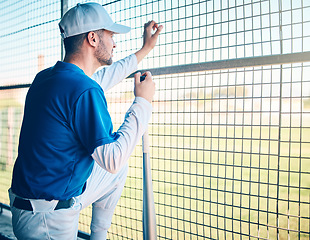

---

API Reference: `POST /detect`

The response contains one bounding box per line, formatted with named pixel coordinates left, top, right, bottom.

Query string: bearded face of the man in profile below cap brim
left=95, top=30, right=116, bottom=66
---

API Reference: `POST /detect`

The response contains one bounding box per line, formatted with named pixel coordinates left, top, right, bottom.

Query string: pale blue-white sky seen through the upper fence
left=0, top=0, right=310, bottom=96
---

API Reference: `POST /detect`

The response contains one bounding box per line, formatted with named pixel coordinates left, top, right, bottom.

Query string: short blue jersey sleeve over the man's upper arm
left=72, top=88, right=119, bottom=154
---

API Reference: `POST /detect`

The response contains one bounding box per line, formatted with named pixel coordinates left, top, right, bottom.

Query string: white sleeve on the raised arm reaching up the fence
left=92, top=54, right=138, bottom=91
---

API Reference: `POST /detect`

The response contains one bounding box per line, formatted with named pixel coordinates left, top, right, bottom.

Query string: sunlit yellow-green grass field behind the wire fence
left=0, top=122, right=310, bottom=239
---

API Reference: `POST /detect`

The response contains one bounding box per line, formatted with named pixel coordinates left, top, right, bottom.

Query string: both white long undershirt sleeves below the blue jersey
left=92, top=54, right=152, bottom=173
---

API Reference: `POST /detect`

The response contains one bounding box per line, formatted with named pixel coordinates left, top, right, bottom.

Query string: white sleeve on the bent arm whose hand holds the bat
left=92, top=97, right=152, bottom=173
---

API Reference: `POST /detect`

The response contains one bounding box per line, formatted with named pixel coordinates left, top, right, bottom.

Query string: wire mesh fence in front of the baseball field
left=0, top=0, right=310, bottom=239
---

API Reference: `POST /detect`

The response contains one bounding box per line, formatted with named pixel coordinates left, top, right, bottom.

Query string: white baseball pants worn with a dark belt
left=9, top=162, right=128, bottom=240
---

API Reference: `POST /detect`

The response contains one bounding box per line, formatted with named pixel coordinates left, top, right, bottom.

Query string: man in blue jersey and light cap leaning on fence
left=9, top=3, right=162, bottom=239
